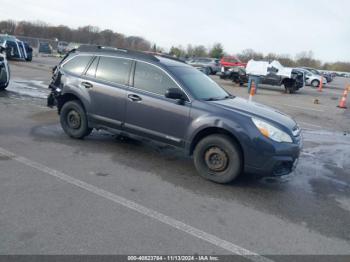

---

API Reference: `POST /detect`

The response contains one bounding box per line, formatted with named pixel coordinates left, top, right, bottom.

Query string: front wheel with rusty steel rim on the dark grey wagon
left=193, top=134, right=242, bottom=184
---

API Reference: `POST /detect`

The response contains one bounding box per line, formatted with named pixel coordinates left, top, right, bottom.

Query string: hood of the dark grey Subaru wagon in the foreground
left=214, top=97, right=296, bottom=131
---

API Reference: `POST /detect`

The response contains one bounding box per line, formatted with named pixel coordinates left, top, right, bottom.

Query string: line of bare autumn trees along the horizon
left=0, top=20, right=350, bottom=72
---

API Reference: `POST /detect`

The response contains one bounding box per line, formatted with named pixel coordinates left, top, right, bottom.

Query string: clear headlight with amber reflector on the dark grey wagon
left=252, top=118, right=293, bottom=143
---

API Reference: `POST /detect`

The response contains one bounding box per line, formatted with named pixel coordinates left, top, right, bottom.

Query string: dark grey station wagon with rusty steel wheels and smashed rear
left=48, top=46, right=302, bottom=183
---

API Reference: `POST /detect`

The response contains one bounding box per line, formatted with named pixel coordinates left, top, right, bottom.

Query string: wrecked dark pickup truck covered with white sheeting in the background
left=246, top=60, right=305, bottom=94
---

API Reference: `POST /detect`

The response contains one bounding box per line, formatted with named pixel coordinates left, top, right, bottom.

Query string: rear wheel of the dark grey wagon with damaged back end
left=60, top=100, right=92, bottom=139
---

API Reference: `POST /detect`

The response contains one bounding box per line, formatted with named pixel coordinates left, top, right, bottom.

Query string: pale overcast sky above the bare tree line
left=0, top=0, right=350, bottom=62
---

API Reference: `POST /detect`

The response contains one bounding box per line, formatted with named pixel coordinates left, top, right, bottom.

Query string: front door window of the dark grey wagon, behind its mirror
left=134, top=62, right=178, bottom=95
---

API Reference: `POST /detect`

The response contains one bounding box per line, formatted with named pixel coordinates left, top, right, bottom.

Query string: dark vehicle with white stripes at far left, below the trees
left=0, top=35, right=33, bottom=61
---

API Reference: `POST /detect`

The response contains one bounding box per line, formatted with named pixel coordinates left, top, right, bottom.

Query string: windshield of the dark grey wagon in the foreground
left=171, top=66, right=231, bottom=100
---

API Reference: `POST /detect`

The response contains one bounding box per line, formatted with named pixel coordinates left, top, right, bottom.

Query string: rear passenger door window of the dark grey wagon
left=96, top=57, right=132, bottom=85
